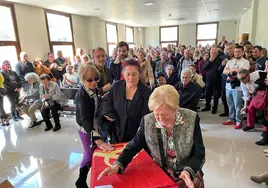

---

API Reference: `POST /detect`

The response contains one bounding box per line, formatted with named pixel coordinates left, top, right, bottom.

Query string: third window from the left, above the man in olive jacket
left=106, top=22, right=118, bottom=56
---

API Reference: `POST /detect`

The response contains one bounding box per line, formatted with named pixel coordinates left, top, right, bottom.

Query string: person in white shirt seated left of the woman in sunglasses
left=62, top=65, right=79, bottom=88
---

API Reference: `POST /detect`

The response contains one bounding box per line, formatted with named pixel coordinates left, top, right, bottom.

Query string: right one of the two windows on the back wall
left=196, top=23, right=218, bottom=46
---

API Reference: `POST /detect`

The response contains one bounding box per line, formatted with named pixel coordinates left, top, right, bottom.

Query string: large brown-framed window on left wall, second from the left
left=45, top=10, right=74, bottom=57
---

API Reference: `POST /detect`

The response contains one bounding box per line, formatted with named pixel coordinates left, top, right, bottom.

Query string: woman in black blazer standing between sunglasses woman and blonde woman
left=102, top=60, right=151, bottom=142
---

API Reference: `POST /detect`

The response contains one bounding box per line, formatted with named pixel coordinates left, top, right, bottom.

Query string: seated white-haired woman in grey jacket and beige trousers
left=18, top=72, right=42, bottom=129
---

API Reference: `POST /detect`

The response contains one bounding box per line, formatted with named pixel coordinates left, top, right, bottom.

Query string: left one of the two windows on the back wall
left=160, top=26, right=178, bottom=47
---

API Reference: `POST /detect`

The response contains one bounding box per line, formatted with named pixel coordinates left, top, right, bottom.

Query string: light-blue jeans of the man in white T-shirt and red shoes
left=226, top=89, right=244, bottom=123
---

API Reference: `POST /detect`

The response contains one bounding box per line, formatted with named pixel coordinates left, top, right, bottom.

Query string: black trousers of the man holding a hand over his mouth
left=206, top=81, right=221, bottom=109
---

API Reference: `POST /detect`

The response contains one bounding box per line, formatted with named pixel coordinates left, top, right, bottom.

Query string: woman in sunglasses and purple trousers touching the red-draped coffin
left=75, top=64, right=113, bottom=188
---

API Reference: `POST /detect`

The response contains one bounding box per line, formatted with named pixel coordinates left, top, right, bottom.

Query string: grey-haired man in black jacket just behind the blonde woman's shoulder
left=175, top=68, right=201, bottom=111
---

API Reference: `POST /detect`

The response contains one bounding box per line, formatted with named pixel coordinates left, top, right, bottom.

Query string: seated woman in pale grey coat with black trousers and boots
left=39, top=74, right=68, bottom=132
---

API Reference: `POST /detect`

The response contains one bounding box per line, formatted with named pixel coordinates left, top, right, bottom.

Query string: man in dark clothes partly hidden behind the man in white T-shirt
left=219, top=42, right=234, bottom=117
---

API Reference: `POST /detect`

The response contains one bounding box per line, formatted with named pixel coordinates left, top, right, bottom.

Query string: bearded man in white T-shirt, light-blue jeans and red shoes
left=223, top=46, right=250, bottom=129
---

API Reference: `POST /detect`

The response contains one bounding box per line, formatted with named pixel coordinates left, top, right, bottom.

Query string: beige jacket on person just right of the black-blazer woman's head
left=140, top=61, right=154, bottom=87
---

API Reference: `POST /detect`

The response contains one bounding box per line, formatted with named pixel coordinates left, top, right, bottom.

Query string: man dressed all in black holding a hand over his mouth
left=202, top=47, right=221, bottom=114
